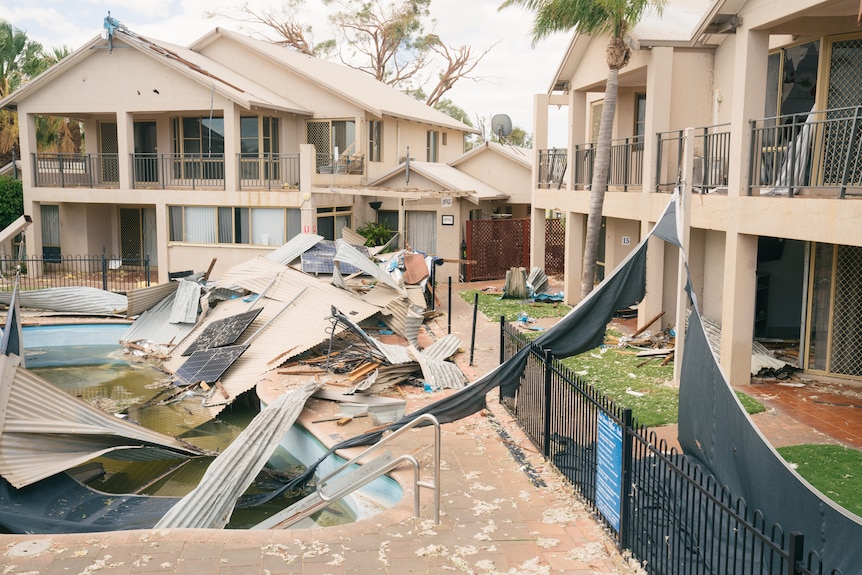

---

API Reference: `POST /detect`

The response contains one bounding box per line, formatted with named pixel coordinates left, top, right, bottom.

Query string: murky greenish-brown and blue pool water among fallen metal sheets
left=16, top=324, right=402, bottom=528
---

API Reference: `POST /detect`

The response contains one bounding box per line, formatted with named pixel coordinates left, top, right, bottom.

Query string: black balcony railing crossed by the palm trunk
left=574, top=136, right=644, bottom=192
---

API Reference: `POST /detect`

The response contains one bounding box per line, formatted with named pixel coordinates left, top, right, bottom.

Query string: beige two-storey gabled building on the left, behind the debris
left=0, top=22, right=530, bottom=281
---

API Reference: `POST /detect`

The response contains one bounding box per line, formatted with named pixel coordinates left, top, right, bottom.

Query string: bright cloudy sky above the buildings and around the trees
left=6, top=0, right=569, bottom=147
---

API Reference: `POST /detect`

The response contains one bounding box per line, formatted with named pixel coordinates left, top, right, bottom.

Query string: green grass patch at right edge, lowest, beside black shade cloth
left=778, top=445, right=862, bottom=516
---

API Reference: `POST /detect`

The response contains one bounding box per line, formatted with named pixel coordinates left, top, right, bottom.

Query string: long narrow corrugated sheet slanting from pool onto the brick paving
left=155, top=383, right=321, bottom=529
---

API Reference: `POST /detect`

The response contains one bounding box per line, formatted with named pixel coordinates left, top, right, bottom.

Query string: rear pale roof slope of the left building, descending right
left=190, top=28, right=478, bottom=133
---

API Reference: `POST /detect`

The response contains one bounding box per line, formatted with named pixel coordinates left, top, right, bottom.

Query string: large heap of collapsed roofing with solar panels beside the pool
left=122, top=233, right=467, bottom=435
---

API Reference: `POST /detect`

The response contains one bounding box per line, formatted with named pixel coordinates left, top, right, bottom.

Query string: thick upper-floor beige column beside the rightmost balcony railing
left=727, top=29, right=769, bottom=196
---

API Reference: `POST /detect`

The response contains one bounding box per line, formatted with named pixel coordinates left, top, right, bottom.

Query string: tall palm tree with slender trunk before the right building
left=500, top=0, right=666, bottom=299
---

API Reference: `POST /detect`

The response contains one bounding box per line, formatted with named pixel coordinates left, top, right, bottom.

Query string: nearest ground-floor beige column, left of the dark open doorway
left=721, top=231, right=757, bottom=385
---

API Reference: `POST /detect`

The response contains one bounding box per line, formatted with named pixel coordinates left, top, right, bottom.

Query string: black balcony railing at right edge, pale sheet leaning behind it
left=748, top=107, right=862, bottom=198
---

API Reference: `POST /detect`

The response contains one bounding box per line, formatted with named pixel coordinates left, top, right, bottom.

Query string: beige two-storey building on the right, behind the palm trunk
left=532, top=0, right=862, bottom=384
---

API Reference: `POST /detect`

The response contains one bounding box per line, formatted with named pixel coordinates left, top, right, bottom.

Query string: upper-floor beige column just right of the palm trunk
left=643, top=47, right=673, bottom=193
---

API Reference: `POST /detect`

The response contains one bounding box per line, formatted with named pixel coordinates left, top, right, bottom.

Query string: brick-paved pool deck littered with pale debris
left=0, top=282, right=643, bottom=575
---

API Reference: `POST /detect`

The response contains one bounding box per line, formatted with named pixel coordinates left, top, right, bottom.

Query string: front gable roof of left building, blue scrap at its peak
left=0, top=29, right=311, bottom=115
